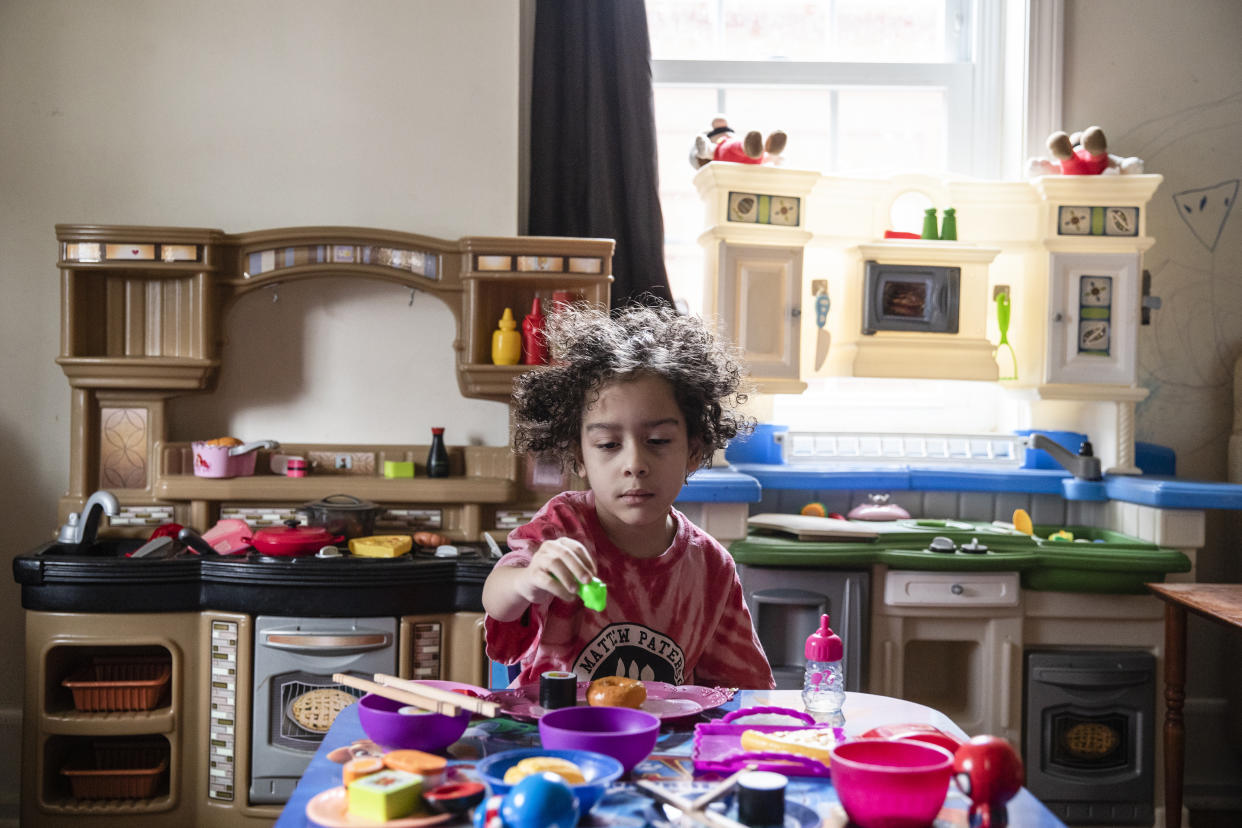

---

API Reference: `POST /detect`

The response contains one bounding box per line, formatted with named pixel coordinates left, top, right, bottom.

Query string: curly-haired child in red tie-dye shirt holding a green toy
left=483, top=305, right=775, bottom=688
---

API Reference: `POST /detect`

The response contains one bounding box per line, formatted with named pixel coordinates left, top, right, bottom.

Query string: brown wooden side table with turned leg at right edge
left=1148, top=583, right=1242, bottom=828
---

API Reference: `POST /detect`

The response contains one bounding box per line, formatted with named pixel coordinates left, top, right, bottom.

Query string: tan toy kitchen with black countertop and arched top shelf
left=15, top=225, right=612, bottom=826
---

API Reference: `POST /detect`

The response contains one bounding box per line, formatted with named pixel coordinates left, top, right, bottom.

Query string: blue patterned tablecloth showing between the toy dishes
left=276, top=690, right=1064, bottom=828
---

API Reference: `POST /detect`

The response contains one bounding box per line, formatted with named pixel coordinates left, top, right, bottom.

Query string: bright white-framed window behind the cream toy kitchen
left=646, top=0, right=1061, bottom=310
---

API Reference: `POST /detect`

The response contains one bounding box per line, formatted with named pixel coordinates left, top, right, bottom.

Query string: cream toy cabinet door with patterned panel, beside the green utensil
left=1046, top=253, right=1139, bottom=385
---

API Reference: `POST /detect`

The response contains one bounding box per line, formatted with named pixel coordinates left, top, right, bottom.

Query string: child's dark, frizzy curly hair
left=513, top=303, right=754, bottom=467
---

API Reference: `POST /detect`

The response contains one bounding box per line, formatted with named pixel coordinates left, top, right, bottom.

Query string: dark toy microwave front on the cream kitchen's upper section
left=862, top=261, right=961, bottom=334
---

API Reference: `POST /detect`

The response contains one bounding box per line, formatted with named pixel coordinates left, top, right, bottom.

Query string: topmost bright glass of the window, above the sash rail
left=647, top=0, right=953, bottom=63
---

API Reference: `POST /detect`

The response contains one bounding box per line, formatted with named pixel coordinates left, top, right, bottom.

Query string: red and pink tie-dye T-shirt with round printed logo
left=486, top=490, right=775, bottom=689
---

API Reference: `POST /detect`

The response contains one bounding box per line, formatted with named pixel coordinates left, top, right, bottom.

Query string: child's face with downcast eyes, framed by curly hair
left=581, top=376, right=698, bottom=545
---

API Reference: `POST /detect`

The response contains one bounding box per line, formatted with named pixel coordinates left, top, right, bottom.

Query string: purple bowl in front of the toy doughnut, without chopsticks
left=539, top=706, right=660, bottom=773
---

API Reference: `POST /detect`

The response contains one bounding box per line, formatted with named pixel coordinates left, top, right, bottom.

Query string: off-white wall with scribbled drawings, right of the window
left=1064, top=0, right=1242, bottom=808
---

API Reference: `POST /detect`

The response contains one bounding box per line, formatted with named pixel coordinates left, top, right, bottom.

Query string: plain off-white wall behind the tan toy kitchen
left=0, top=0, right=519, bottom=808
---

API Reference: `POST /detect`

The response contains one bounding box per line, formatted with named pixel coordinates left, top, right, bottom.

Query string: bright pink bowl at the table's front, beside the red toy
left=828, top=739, right=953, bottom=828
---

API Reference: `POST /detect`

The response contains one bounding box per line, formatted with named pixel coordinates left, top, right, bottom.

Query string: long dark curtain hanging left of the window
left=528, top=0, right=672, bottom=308
